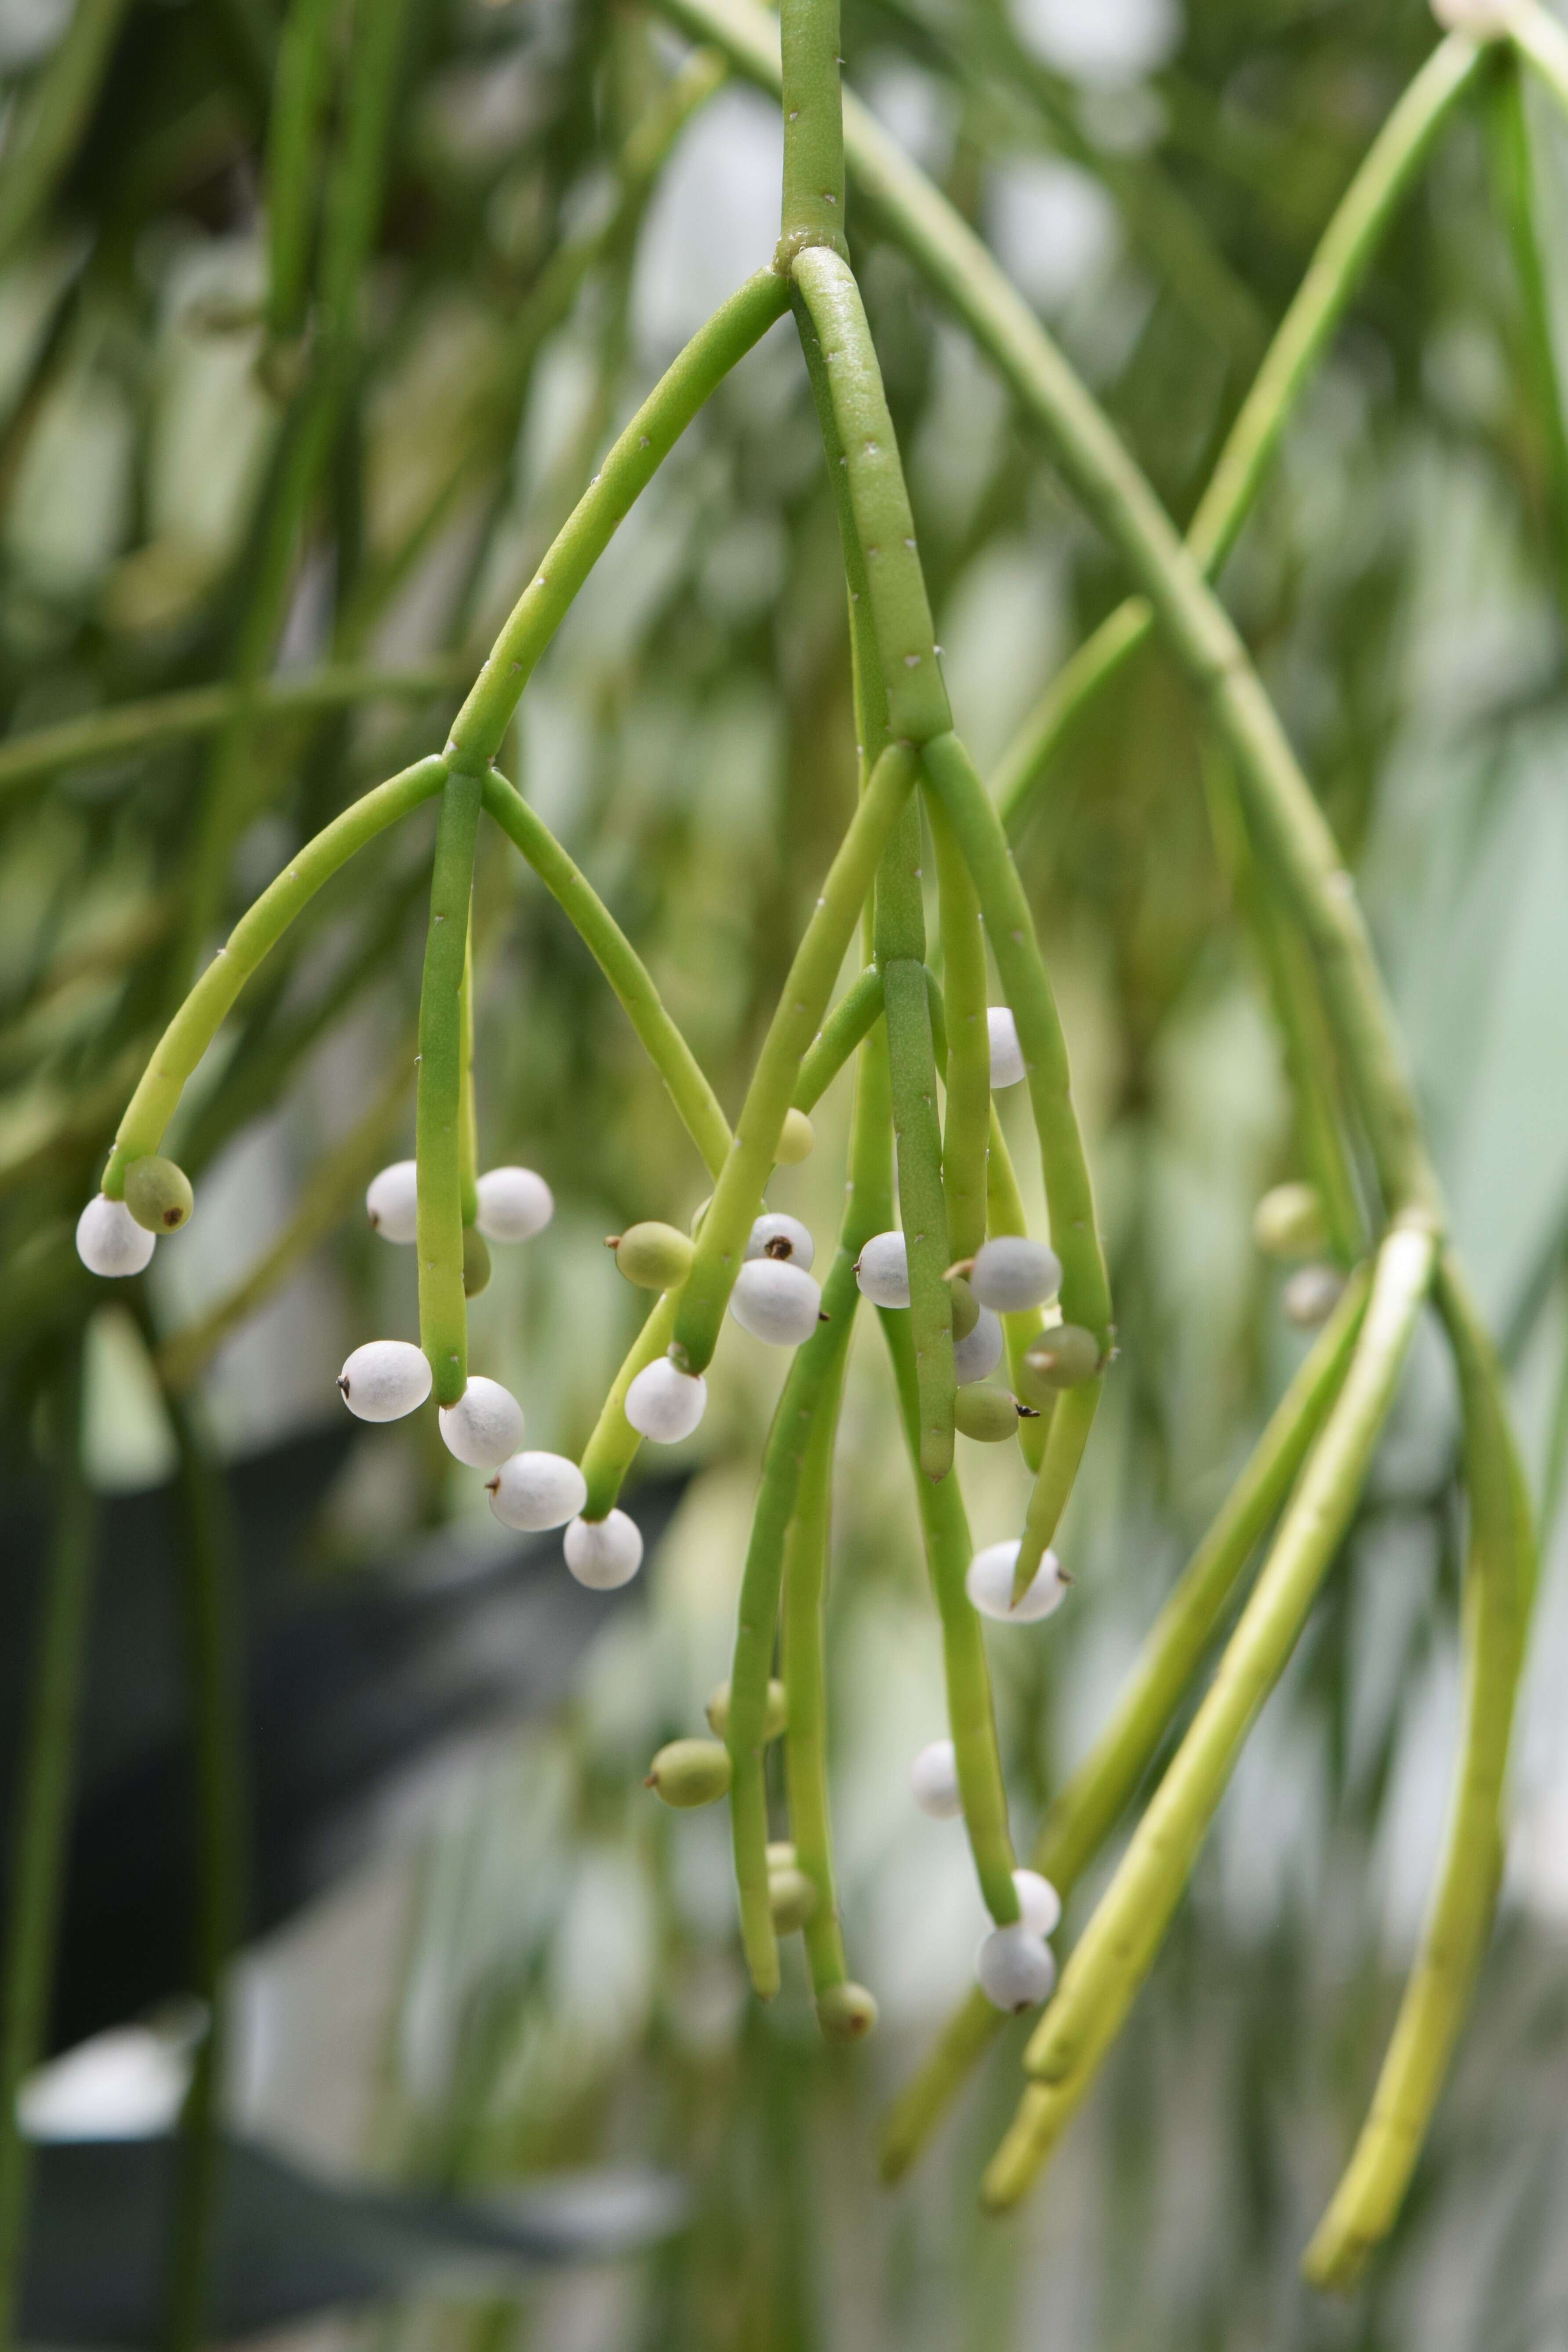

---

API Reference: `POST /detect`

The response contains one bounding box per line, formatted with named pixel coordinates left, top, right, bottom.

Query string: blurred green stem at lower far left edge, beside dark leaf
left=0, top=1348, right=94, bottom=2352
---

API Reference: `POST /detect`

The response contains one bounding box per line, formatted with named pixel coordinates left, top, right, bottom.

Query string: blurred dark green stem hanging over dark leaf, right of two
left=164, top=1390, right=249, bottom=2352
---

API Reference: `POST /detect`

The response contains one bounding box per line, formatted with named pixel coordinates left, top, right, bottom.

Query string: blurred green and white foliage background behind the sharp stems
left=0, top=0, right=1568, bottom=2352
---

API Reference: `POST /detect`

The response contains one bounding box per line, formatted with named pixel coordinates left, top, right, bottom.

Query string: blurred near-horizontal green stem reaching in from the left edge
left=0, top=654, right=468, bottom=802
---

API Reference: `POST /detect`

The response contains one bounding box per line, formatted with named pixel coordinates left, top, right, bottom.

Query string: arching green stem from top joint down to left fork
left=451, top=270, right=790, bottom=774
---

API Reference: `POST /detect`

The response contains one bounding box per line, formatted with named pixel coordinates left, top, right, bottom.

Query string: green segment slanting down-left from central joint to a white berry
left=675, top=743, right=914, bottom=1371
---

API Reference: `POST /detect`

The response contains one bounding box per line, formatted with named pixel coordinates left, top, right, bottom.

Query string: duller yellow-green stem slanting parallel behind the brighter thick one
left=881, top=1273, right=1368, bottom=2181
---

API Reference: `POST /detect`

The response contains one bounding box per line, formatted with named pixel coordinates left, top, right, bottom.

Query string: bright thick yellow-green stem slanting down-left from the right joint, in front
left=985, top=1223, right=1437, bottom=2209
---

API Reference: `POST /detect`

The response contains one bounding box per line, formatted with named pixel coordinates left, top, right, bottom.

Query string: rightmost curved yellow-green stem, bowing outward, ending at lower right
left=1302, top=1254, right=1535, bottom=2289
